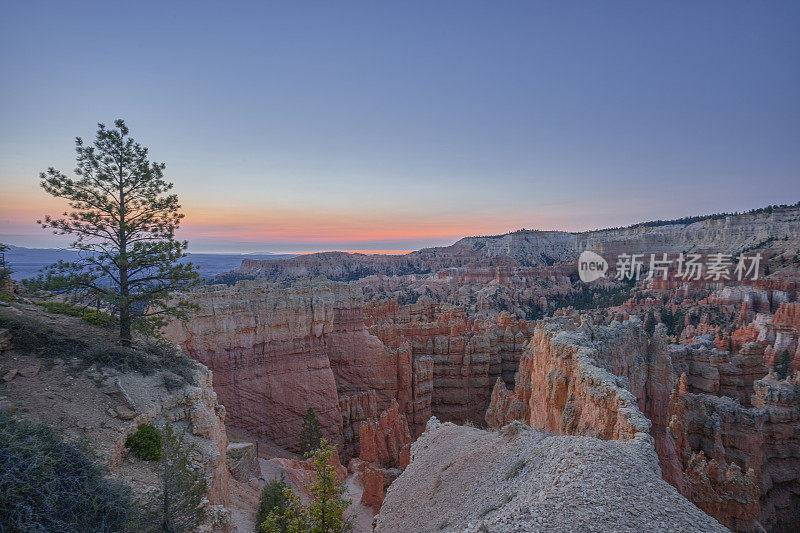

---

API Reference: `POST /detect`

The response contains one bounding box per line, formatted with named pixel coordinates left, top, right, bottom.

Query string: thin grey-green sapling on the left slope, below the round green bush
left=151, top=424, right=208, bottom=533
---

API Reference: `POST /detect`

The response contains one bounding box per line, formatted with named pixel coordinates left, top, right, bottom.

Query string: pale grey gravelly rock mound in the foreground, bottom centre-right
left=377, top=418, right=727, bottom=532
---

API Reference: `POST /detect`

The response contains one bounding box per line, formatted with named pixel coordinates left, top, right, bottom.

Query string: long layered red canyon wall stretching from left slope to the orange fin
left=164, top=280, right=531, bottom=460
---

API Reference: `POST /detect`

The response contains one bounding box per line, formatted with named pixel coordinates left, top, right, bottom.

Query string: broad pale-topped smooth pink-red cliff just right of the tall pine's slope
left=163, top=280, right=400, bottom=454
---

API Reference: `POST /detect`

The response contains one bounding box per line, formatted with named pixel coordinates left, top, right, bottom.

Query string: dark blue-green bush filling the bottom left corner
left=0, top=412, right=133, bottom=532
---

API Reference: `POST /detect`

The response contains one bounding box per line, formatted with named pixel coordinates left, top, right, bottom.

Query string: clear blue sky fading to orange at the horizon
left=0, top=0, right=800, bottom=253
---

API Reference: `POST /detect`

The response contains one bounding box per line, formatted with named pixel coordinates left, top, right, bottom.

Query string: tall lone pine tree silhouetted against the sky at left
left=38, top=120, right=198, bottom=345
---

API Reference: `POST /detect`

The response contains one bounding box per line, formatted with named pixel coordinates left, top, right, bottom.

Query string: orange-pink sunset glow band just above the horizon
left=0, top=187, right=564, bottom=246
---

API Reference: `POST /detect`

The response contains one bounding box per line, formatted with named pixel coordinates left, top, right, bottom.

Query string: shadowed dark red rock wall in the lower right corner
left=669, top=339, right=800, bottom=531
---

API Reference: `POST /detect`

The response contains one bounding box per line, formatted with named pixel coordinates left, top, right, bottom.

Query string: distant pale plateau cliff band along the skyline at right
left=231, top=206, right=800, bottom=281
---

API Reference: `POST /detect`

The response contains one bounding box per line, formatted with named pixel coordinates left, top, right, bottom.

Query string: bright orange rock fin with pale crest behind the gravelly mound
left=486, top=319, right=671, bottom=440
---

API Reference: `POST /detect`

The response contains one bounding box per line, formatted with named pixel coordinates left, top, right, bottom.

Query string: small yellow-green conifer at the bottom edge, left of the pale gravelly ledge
left=306, top=439, right=351, bottom=533
